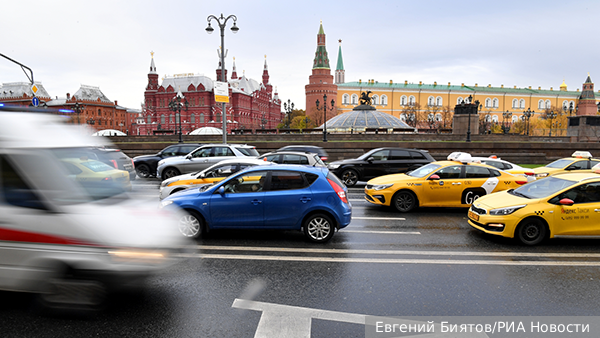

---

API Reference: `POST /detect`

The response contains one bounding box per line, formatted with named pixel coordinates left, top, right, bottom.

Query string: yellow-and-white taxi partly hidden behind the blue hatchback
left=160, top=157, right=275, bottom=200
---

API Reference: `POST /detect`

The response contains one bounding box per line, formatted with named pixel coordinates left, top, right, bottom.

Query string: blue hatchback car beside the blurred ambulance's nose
left=161, top=165, right=352, bottom=243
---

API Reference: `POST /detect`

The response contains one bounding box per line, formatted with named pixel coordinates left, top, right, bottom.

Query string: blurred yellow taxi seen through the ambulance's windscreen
left=61, top=157, right=131, bottom=192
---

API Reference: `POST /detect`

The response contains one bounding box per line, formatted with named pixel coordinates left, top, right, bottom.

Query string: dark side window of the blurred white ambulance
left=0, top=156, right=46, bottom=210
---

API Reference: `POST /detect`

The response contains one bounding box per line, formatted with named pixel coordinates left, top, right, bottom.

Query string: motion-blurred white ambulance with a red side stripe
left=0, top=104, right=188, bottom=312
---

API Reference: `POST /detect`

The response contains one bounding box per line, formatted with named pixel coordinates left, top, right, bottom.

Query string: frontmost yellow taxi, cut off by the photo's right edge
left=468, top=172, right=600, bottom=245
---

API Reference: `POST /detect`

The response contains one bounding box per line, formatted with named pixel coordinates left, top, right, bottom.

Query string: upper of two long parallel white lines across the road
left=192, top=245, right=600, bottom=258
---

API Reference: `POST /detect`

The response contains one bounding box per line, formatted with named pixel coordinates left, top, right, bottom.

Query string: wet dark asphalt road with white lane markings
left=0, top=180, right=600, bottom=337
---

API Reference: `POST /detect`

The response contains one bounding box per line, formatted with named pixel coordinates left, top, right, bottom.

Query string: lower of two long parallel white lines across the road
left=186, top=254, right=600, bottom=267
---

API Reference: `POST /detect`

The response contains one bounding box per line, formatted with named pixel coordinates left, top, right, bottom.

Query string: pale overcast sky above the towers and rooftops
left=0, top=0, right=600, bottom=109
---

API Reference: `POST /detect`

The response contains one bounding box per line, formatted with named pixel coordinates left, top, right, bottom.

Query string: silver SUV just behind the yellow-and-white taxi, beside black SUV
left=156, top=144, right=259, bottom=180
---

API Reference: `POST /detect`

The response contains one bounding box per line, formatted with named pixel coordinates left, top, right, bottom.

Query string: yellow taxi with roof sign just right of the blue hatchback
left=365, top=152, right=527, bottom=212
